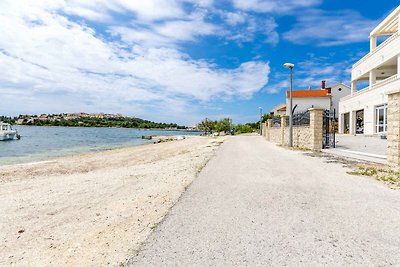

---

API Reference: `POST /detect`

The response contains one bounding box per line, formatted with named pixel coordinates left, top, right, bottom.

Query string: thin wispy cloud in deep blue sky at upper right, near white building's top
left=283, top=10, right=378, bottom=46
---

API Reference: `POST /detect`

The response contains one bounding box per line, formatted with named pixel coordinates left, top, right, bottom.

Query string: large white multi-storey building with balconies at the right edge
left=339, top=6, right=400, bottom=135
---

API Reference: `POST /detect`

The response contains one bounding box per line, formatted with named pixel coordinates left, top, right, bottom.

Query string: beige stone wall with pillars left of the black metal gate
left=265, top=109, right=323, bottom=151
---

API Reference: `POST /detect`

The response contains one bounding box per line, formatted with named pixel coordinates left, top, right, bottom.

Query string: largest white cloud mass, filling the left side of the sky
left=0, top=0, right=269, bottom=122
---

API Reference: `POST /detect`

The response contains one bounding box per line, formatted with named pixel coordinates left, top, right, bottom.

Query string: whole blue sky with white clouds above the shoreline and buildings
left=0, top=0, right=399, bottom=125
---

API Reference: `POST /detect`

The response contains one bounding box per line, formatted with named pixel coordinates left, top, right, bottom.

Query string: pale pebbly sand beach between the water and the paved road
left=0, top=137, right=224, bottom=266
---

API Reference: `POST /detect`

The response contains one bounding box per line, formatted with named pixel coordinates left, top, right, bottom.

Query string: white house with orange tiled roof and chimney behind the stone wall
left=286, top=81, right=350, bottom=114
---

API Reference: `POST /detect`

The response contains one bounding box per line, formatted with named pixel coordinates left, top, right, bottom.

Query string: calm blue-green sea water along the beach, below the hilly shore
left=0, top=126, right=200, bottom=165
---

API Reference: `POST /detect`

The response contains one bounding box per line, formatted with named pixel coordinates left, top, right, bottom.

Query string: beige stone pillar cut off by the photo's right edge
left=387, top=88, right=400, bottom=165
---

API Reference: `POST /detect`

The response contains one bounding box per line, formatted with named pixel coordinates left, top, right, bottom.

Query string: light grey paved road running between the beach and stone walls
left=130, top=136, right=400, bottom=266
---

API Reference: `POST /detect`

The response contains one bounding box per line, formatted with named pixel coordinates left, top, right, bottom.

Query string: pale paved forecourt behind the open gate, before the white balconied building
left=324, top=134, right=387, bottom=164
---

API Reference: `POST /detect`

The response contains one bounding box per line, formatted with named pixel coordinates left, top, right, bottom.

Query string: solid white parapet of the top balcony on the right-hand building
left=351, top=32, right=400, bottom=81
